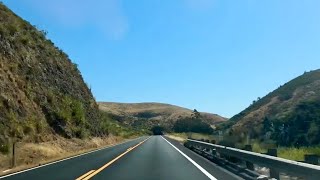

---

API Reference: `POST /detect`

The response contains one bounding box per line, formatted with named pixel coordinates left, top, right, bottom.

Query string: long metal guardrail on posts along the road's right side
left=187, top=139, right=320, bottom=180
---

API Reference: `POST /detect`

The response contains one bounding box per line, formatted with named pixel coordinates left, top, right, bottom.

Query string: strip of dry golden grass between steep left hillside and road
left=0, top=135, right=125, bottom=175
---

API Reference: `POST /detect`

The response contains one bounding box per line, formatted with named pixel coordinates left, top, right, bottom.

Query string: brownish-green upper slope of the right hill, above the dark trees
left=230, top=70, right=320, bottom=131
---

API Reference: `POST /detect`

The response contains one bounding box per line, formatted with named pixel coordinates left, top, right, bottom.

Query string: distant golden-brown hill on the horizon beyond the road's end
left=98, top=102, right=227, bottom=128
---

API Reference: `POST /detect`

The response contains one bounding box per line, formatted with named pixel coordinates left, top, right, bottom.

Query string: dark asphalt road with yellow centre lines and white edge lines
left=0, top=136, right=240, bottom=180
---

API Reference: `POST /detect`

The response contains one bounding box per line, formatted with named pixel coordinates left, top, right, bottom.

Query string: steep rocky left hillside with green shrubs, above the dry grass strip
left=0, top=4, right=99, bottom=141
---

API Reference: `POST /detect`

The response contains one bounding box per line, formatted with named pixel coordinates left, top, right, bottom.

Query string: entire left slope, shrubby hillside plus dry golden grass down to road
left=0, top=2, right=145, bottom=170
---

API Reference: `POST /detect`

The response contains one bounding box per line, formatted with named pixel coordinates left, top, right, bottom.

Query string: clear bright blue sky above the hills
left=3, top=0, right=320, bottom=117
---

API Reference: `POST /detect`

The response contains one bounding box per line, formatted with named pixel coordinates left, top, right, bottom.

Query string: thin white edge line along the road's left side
left=0, top=137, right=142, bottom=179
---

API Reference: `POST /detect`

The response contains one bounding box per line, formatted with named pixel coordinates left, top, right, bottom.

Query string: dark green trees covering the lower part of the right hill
left=263, top=100, right=320, bottom=147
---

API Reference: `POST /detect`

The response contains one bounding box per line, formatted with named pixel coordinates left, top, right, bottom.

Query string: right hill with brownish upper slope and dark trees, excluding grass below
left=228, top=70, right=320, bottom=145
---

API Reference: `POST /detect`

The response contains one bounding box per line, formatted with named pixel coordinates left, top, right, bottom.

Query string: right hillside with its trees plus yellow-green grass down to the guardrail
left=206, top=70, right=320, bottom=161
